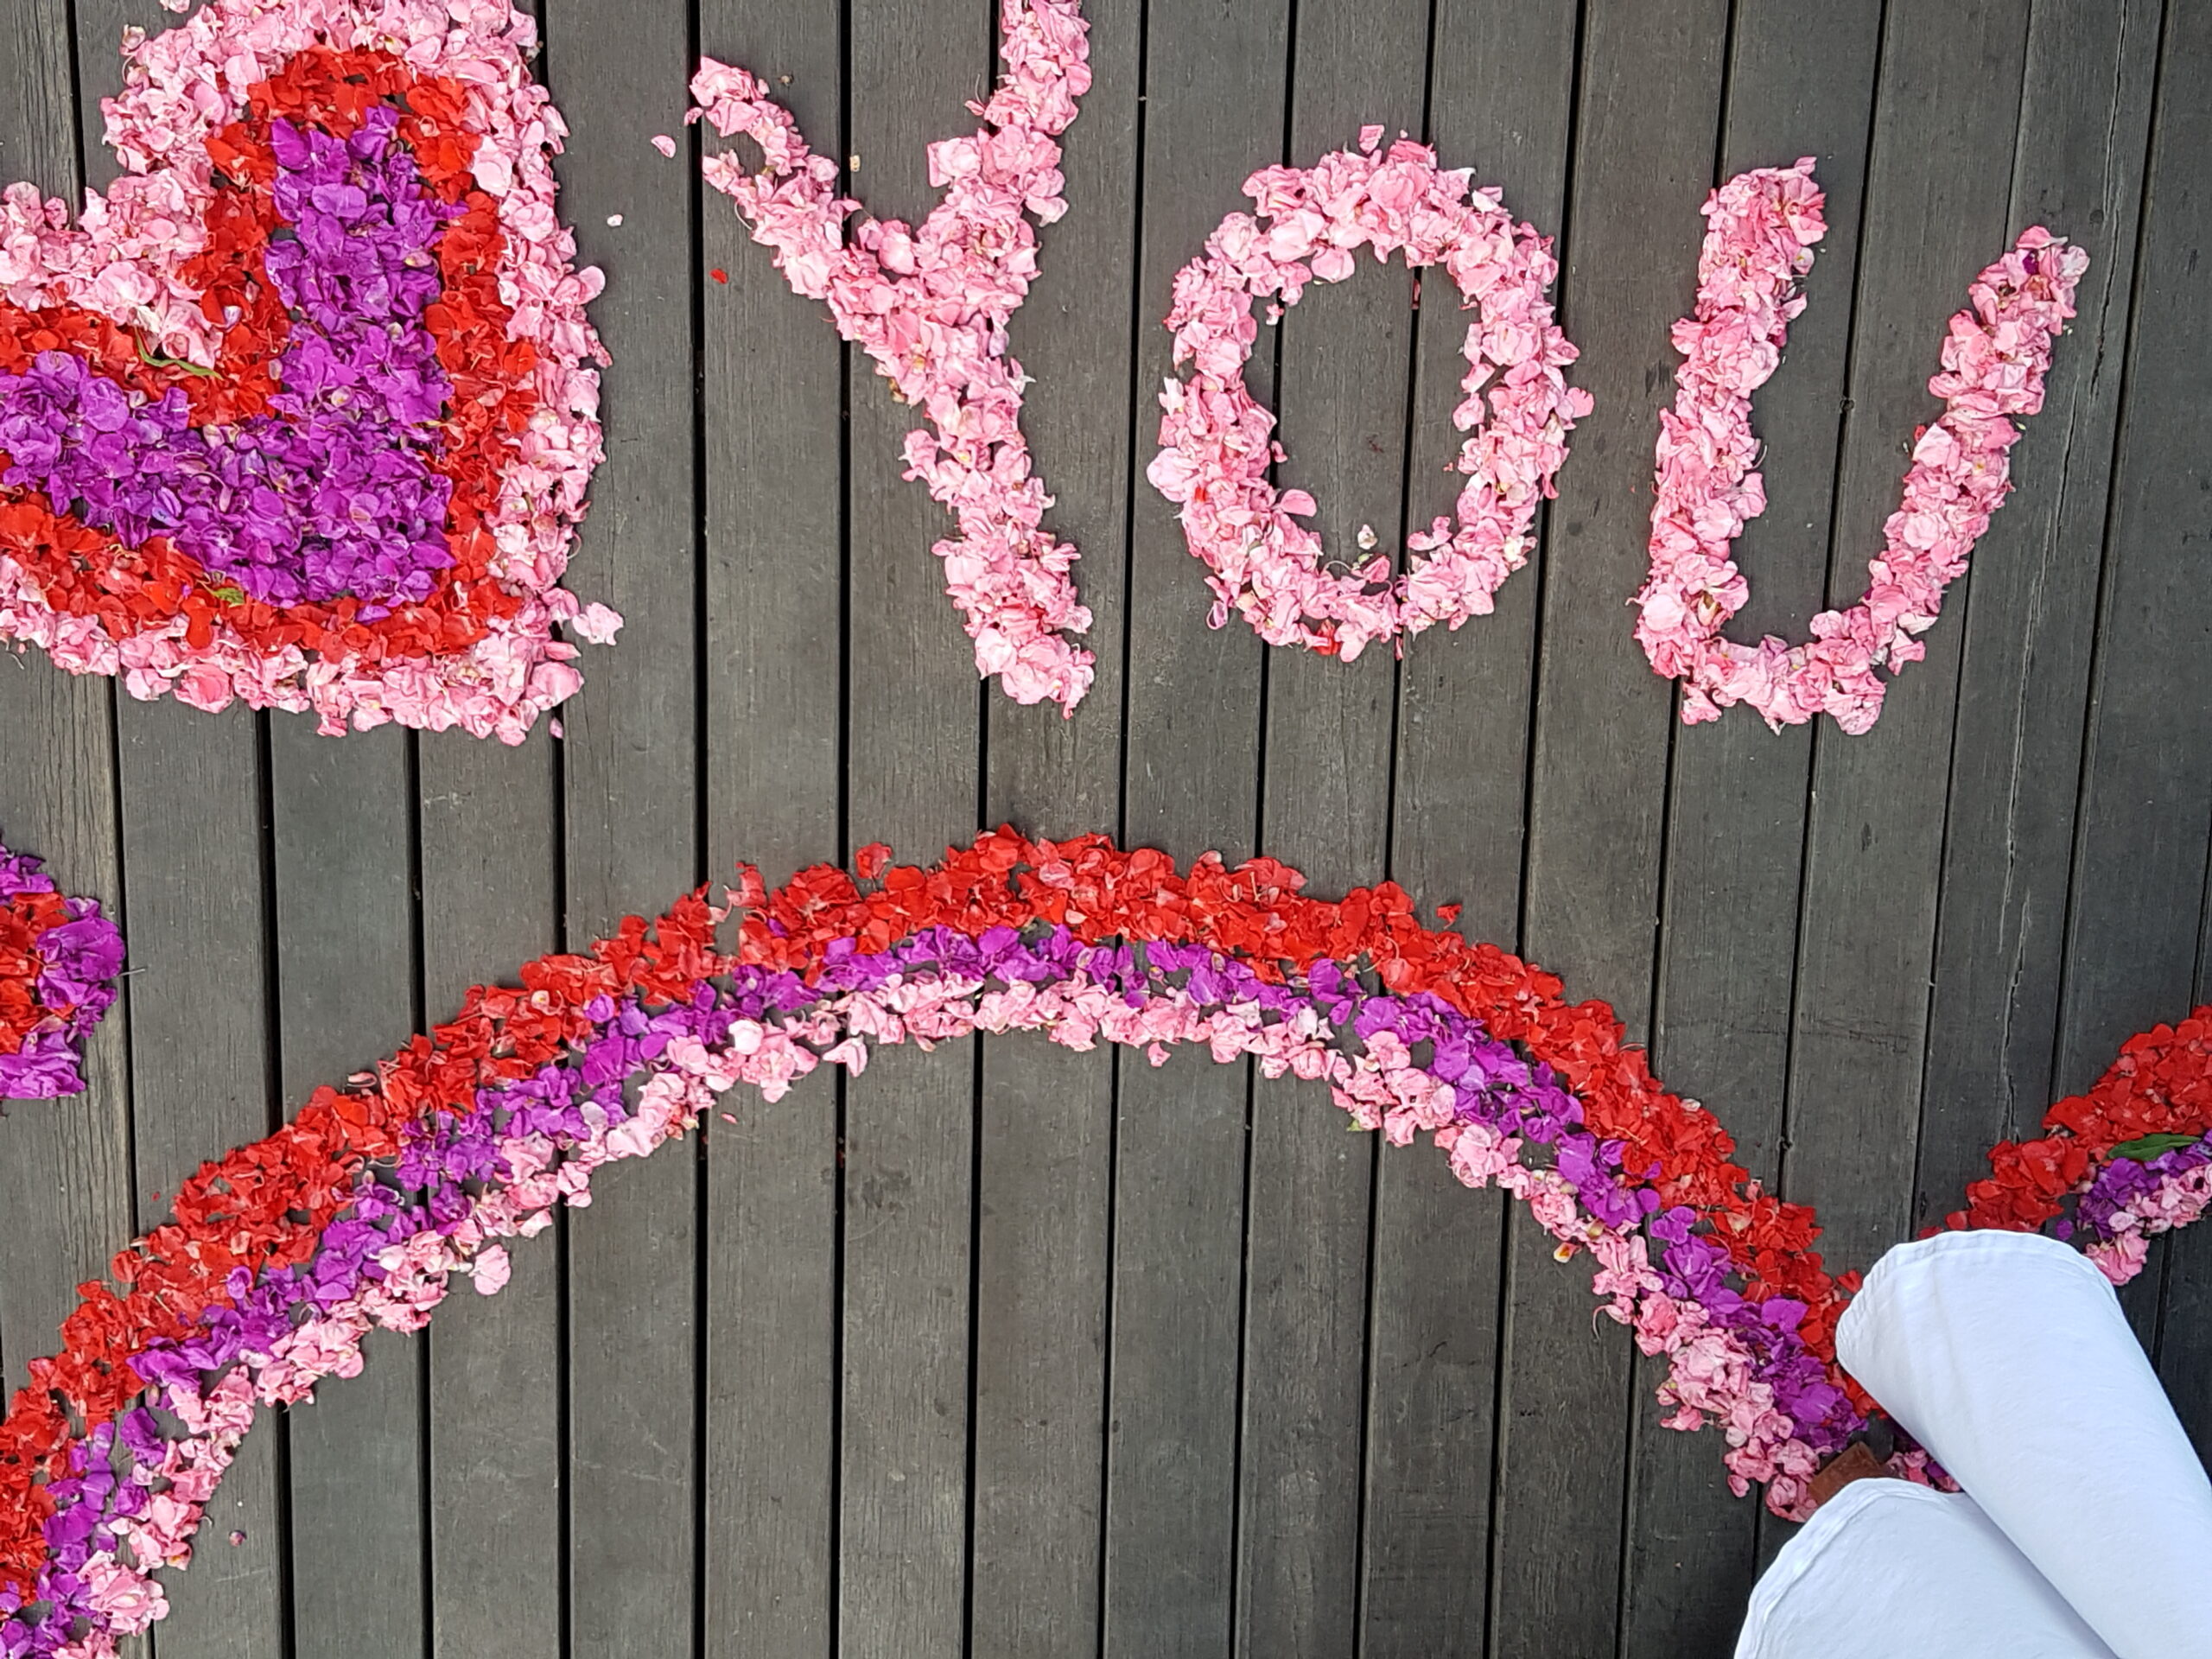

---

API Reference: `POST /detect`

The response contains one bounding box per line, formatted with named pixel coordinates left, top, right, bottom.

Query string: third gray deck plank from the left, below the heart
left=270, top=715, right=429, bottom=1655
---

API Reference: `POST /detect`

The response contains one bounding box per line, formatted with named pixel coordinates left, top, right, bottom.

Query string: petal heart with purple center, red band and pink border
left=0, top=0, right=620, bottom=741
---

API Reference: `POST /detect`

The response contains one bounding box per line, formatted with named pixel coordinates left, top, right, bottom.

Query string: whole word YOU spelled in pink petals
left=690, top=0, right=2088, bottom=732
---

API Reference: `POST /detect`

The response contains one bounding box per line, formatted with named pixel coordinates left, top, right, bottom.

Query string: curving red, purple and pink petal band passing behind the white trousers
left=0, top=830, right=2212, bottom=1656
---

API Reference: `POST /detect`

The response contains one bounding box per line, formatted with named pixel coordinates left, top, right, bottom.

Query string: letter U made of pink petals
left=1637, top=157, right=2088, bottom=734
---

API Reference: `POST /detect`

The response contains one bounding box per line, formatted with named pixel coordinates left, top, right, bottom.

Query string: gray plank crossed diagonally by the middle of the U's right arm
left=1783, top=0, right=2029, bottom=1268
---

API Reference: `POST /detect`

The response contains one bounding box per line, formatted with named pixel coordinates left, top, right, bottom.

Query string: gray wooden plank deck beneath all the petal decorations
left=0, top=0, right=2212, bottom=1659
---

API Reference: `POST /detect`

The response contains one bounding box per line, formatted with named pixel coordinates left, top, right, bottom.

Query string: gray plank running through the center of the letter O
left=1230, top=0, right=1424, bottom=1655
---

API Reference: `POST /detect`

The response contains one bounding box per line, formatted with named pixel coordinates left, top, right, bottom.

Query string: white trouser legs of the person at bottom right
left=1737, top=1232, right=2212, bottom=1659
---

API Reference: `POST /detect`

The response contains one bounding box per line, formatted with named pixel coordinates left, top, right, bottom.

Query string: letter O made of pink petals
left=1146, top=126, right=1591, bottom=659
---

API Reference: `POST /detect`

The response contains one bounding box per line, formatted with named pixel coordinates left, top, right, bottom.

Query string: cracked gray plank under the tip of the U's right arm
left=1913, top=0, right=2161, bottom=1225
